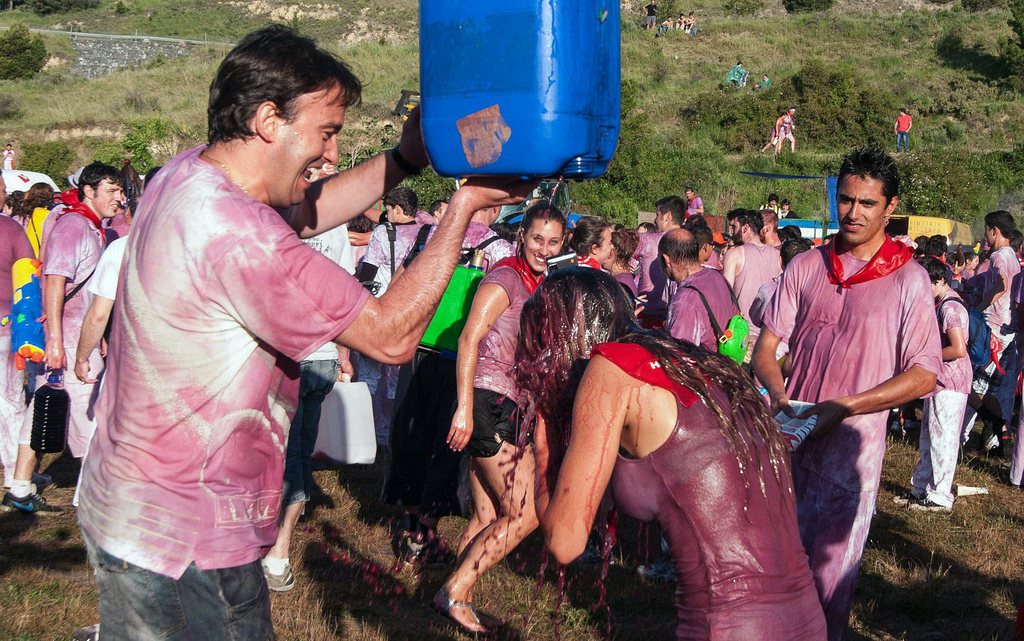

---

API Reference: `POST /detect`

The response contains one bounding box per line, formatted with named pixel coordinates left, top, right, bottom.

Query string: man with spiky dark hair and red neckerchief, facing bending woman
left=754, top=148, right=942, bottom=641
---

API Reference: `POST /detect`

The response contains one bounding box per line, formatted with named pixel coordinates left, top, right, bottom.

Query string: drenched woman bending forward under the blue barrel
left=516, top=267, right=825, bottom=641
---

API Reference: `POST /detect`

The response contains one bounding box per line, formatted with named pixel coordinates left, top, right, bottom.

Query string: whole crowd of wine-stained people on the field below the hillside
left=0, top=22, right=1024, bottom=641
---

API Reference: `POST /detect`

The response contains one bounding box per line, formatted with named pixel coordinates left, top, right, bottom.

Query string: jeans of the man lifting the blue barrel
left=82, top=531, right=274, bottom=641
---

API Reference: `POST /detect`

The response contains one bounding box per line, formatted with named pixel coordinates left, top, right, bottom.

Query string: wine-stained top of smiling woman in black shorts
left=473, top=266, right=529, bottom=402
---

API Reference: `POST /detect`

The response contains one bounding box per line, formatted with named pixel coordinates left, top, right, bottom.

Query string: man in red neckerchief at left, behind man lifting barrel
left=3, top=163, right=124, bottom=512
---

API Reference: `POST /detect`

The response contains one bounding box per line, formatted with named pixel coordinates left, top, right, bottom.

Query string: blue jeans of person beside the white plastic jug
left=284, top=360, right=338, bottom=506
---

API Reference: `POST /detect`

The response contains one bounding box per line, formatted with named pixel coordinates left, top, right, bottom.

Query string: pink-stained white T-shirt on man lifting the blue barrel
left=79, top=147, right=369, bottom=579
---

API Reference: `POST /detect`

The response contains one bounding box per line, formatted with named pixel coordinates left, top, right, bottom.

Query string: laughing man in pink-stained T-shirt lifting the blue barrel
left=79, top=27, right=534, bottom=641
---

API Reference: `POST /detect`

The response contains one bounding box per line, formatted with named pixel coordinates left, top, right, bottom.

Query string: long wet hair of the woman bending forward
left=516, top=268, right=790, bottom=494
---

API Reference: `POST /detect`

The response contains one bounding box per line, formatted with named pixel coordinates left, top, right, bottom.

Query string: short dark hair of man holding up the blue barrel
left=207, top=25, right=362, bottom=144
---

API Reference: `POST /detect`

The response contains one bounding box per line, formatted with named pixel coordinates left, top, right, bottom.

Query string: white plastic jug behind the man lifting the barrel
left=313, top=382, right=377, bottom=465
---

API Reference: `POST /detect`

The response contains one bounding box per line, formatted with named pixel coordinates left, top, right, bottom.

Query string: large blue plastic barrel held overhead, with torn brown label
left=420, top=0, right=621, bottom=178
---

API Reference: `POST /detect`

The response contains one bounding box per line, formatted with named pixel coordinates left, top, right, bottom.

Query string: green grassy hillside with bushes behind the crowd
left=0, top=0, right=1024, bottom=229
